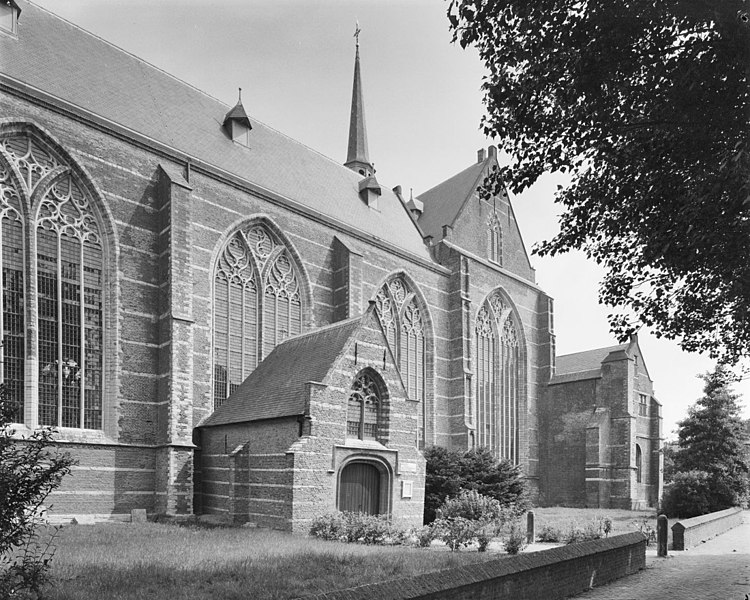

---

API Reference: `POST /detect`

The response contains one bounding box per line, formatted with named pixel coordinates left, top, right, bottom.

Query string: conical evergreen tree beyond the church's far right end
left=673, top=365, right=748, bottom=516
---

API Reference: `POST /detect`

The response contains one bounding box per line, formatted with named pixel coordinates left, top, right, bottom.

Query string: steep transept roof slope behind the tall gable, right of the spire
left=419, top=158, right=494, bottom=242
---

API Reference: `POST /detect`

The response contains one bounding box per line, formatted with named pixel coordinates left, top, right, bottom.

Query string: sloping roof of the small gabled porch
left=200, top=317, right=362, bottom=427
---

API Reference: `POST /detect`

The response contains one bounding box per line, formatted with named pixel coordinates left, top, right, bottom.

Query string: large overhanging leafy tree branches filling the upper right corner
left=448, top=0, right=750, bottom=364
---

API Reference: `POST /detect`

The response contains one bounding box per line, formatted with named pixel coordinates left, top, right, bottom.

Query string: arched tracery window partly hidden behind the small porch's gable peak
left=375, top=277, right=427, bottom=446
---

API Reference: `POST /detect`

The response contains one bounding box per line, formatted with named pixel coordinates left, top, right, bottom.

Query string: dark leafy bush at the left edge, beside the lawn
left=0, top=384, right=74, bottom=598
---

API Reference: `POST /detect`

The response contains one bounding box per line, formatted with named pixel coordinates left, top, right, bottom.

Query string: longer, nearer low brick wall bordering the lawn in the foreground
left=305, top=532, right=646, bottom=600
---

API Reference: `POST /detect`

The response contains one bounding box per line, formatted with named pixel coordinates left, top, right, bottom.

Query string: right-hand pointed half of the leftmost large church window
left=36, top=176, right=102, bottom=429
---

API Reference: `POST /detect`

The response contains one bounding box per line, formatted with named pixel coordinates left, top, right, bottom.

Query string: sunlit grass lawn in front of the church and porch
left=45, top=523, right=506, bottom=600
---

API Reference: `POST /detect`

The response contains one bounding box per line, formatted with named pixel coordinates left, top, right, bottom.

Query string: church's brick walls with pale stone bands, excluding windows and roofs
left=0, top=7, right=660, bottom=520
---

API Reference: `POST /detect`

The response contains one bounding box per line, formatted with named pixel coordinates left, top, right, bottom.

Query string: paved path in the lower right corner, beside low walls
left=575, top=511, right=750, bottom=600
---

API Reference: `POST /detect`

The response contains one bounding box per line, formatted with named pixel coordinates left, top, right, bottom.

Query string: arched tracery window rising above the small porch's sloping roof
left=213, top=223, right=302, bottom=408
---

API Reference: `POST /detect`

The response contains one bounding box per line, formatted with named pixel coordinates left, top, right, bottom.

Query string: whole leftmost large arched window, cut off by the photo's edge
left=0, top=134, right=104, bottom=429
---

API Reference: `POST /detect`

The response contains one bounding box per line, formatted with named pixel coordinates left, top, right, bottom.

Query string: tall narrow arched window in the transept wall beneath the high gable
left=475, top=293, right=521, bottom=463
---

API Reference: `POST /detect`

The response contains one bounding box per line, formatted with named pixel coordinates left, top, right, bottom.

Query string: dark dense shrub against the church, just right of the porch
left=424, top=446, right=528, bottom=523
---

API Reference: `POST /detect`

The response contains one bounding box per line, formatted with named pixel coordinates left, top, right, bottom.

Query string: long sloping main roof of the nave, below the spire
left=0, top=0, right=431, bottom=260
